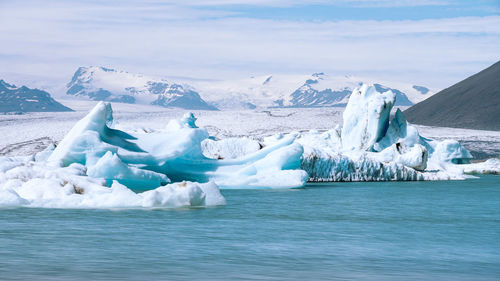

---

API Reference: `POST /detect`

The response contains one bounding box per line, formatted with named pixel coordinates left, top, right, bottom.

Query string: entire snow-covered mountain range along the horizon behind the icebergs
left=66, top=67, right=434, bottom=109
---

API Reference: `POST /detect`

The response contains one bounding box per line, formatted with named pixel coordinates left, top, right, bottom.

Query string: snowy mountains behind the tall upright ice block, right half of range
left=193, top=73, right=434, bottom=108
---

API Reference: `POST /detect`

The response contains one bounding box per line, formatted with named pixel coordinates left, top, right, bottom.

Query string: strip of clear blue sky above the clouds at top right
left=204, top=0, right=500, bottom=21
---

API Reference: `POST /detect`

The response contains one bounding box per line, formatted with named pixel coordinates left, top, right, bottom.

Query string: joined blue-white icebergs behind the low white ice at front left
left=42, top=85, right=496, bottom=188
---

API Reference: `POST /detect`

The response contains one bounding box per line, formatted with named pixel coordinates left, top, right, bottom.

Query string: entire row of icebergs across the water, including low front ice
left=0, top=82, right=500, bottom=208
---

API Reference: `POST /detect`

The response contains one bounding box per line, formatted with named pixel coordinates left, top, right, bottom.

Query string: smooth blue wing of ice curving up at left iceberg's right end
left=149, top=131, right=307, bottom=188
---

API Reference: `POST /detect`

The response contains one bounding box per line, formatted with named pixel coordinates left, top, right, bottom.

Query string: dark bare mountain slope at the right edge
left=404, top=61, right=500, bottom=131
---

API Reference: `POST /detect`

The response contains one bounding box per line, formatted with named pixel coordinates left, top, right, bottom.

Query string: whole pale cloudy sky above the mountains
left=0, top=0, right=500, bottom=92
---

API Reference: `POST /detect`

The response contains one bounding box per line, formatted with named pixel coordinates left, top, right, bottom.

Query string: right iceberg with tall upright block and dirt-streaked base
left=292, top=84, right=486, bottom=181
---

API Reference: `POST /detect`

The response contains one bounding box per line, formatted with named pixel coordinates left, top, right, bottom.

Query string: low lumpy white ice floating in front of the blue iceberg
left=0, top=155, right=225, bottom=208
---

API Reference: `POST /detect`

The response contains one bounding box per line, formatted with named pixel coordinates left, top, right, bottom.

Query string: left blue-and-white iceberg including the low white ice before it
left=0, top=99, right=308, bottom=208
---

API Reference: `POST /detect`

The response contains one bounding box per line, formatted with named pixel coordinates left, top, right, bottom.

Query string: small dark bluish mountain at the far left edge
left=0, top=80, right=72, bottom=112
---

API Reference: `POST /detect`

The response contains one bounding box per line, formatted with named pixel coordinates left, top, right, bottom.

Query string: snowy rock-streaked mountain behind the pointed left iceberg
left=66, top=66, right=217, bottom=110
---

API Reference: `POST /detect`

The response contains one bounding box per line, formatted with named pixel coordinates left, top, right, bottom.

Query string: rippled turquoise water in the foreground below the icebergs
left=0, top=176, right=500, bottom=280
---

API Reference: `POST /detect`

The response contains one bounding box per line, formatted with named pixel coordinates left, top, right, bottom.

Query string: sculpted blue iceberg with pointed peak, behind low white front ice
left=48, top=102, right=307, bottom=189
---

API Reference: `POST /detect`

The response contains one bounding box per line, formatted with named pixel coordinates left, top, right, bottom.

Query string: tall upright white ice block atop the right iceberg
left=341, top=84, right=396, bottom=150
